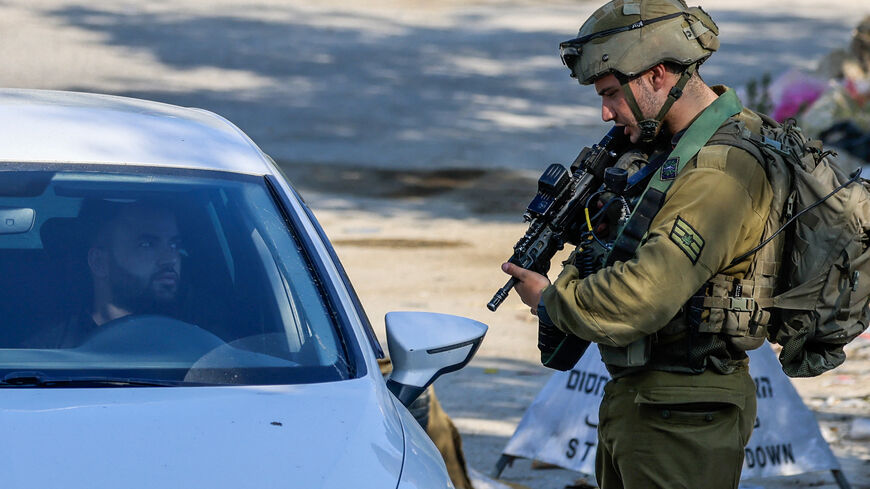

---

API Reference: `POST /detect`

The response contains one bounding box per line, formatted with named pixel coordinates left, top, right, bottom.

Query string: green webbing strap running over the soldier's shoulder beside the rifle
left=607, top=90, right=743, bottom=265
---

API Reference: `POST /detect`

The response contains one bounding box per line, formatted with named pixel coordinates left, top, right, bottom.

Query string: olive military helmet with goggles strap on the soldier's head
left=559, top=0, right=719, bottom=85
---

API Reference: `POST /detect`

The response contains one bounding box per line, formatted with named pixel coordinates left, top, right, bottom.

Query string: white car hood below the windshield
left=0, top=378, right=403, bottom=489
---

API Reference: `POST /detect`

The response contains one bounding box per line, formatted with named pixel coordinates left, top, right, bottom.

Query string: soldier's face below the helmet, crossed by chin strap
left=595, top=73, right=653, bottom=143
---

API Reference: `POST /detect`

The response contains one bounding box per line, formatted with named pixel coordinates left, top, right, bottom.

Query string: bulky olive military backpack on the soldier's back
left=708, top=114, right=870, bottom=377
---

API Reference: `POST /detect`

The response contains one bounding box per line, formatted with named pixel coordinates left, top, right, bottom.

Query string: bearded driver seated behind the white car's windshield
left=29, top=201, right=184, bottom=348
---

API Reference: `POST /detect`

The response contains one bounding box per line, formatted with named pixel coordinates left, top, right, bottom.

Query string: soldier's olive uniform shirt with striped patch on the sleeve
left=542, top=109, right=773, bottom=346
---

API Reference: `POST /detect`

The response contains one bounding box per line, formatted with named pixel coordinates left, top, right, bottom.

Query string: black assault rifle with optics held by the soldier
left=486, top=126, right=628, bottom=311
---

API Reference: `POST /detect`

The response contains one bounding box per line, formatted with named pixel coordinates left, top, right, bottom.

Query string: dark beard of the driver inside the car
left=109, top=257, right=179, bottom=316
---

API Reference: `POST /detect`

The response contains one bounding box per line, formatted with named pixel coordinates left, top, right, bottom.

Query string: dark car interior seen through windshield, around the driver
left=0, top=171, right=346, bottom=386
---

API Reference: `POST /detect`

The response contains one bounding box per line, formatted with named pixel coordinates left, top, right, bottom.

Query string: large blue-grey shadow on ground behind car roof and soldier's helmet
left=35, top=2, right=853, bottom=173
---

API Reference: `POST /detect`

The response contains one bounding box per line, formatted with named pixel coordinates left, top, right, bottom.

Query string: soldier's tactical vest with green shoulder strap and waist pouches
left=599, top=91, right=764, bottom=377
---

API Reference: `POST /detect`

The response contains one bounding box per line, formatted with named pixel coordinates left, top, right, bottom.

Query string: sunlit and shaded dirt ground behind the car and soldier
left=0, top=0, right=870, bottom=489
